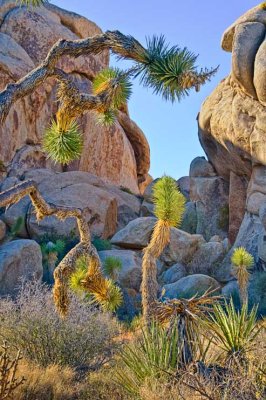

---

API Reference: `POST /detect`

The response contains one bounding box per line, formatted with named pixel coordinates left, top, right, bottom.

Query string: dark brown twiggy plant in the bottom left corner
left=0, top=341, right=25, bottom=400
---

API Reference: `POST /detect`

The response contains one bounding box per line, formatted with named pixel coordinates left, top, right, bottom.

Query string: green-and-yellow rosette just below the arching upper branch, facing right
left=92, top=68, right=132, bottom=110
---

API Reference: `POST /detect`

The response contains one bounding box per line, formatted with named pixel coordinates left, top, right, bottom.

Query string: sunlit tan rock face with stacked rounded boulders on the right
left=198, top=6, right=266, bottom=247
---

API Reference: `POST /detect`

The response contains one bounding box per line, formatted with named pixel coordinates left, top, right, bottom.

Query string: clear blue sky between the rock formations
left=52, top=0, right=259, bottom=178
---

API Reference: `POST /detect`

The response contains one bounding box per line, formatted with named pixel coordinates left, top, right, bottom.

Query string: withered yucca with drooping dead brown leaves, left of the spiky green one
left=154, top=290, right=220, bottom=365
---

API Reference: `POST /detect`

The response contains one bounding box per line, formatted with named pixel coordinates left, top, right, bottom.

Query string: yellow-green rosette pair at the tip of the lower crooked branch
left=69, top=256, right=123, bottom=312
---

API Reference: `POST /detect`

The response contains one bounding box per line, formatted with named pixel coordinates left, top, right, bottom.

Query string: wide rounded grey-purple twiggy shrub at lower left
left=0, top=283, right=116, bottom=369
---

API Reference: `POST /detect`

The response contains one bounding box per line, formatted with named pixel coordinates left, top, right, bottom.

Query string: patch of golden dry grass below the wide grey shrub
left=14, top=361, right=87, bottom=400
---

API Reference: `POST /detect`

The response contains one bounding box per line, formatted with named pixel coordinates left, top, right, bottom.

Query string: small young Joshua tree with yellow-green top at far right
left=231, top=247, right=254, bottom=304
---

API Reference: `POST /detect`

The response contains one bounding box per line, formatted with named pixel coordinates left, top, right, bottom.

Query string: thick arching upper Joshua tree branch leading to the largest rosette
left=0, top=31, right=146, bottom=123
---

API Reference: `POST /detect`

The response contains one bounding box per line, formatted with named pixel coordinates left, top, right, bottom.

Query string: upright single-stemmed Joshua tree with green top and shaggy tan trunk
left=141, top=176, right=186, bottom=325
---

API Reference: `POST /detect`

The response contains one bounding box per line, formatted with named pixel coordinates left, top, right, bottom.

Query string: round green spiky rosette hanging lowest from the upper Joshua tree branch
left=43, top=120, right=83, bottom=164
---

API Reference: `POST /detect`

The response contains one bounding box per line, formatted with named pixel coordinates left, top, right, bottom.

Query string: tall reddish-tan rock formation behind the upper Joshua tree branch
left=0, top=0, right=149, bottom=193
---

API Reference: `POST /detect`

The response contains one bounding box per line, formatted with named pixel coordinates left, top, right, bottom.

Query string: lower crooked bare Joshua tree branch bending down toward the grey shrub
left=0, top=180, right=100, bottom=316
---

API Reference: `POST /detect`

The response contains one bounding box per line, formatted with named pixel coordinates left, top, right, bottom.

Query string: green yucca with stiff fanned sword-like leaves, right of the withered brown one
left=209, top=299, right=262, bottom=362
